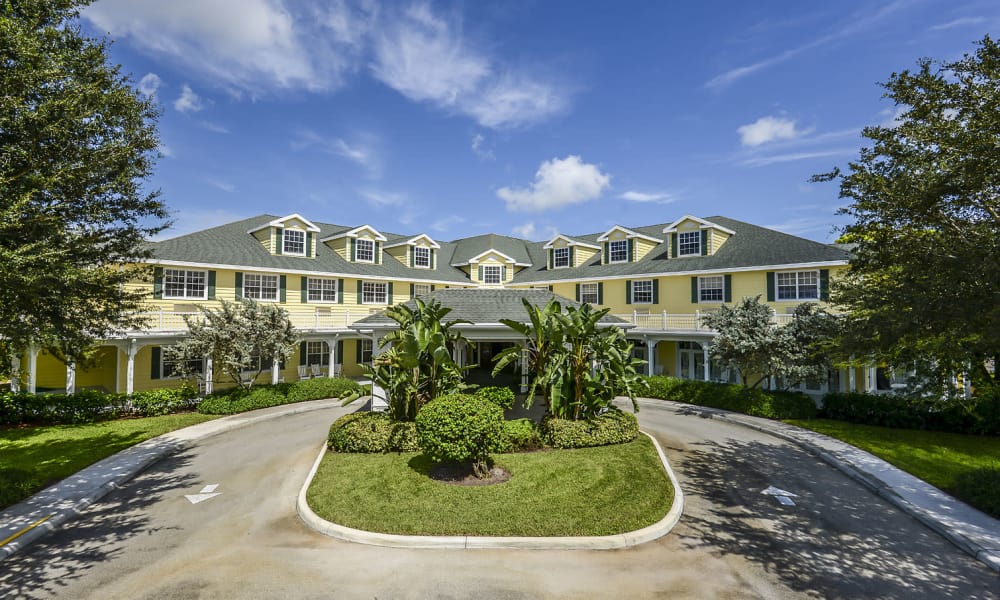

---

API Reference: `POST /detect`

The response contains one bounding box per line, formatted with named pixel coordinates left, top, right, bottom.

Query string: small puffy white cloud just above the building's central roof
left=497, top=155, right=611, bottom=212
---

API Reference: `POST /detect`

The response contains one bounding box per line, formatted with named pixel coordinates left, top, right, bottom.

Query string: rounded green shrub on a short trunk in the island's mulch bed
left=416, top=394, right=507, bottom=478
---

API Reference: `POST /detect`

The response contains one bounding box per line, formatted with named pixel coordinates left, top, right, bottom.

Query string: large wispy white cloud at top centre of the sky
left=372, top=4, right=568, bottom=129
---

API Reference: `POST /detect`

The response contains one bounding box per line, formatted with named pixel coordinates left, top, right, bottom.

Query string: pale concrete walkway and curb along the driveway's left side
left=0, top=398, right=348, bottom=561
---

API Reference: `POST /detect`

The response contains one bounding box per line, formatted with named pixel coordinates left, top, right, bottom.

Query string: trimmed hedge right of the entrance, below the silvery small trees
left=647, top=375, right=817, bottom=419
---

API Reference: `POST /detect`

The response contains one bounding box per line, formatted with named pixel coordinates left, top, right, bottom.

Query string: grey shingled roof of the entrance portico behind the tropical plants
left=352, top=288, right=631, bottom=329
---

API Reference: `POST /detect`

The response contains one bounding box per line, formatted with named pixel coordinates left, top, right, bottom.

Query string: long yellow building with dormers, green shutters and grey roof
left=14, top=214, right=876, bottom=393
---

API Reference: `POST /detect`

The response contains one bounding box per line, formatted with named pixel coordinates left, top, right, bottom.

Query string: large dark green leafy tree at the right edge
left=813, top=36, right=1000, bottom=394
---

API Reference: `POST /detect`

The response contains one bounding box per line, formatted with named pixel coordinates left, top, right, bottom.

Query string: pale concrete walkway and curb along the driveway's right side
left=648, top=399, right=1000, bottom=573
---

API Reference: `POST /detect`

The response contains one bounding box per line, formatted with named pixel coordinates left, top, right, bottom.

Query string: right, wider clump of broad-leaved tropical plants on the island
left=493, top=300, right=645, bottom=420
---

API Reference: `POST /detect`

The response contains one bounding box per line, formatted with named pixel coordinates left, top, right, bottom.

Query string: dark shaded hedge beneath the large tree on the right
left=820, top=392, right=1000, bottom=435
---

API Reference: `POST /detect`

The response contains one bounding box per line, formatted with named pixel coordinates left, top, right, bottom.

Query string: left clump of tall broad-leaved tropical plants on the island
left=365, top=298, right=471, bottom=421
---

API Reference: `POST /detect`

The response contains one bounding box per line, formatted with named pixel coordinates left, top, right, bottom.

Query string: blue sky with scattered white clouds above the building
left=83, top=0, right=1000, bottom=241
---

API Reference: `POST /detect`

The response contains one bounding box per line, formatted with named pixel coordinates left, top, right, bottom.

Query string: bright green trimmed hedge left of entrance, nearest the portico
left=198, top=377, right=363, bottom=415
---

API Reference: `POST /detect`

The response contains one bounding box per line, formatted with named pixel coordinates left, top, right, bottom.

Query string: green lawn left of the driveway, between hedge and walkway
left=0, top=413, right=218, bottom=508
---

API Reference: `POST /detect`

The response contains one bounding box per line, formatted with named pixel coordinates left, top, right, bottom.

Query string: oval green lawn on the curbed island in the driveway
left=307, top=436, right=673, bottom=536
